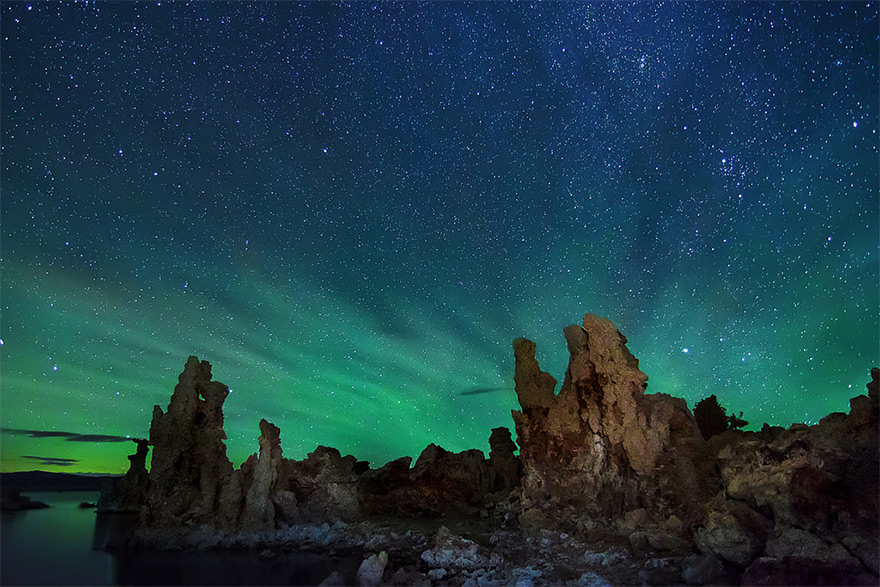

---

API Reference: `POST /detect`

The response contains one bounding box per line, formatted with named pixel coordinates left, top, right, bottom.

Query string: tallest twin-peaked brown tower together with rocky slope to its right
left=513, top=314, right=880, bottom=585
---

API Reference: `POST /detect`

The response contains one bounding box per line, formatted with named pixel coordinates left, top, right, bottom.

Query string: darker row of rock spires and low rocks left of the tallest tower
left=99, top=357, right=519, bottom=532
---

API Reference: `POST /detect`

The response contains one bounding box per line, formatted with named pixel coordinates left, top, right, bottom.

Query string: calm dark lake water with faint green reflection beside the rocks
left=0, top=492, right=361, bottom=586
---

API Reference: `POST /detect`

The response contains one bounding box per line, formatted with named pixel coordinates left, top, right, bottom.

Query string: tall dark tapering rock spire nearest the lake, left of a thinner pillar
left=142, top=357, right=232, bottom=526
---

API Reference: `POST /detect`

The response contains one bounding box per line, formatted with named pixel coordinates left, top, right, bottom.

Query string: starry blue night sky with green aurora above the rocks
left=0, top=2, right=880, bottom=473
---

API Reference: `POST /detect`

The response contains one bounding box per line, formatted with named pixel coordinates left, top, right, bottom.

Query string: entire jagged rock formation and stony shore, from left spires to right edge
left=99, top=314, right=880, bottom=585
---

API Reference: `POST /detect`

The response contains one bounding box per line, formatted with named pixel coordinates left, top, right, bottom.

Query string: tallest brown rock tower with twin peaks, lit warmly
left=513, top=314, right=717, bottom=526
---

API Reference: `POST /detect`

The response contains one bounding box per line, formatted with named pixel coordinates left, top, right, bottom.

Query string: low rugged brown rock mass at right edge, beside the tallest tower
left=697, top=369, right=880, bottom=585
